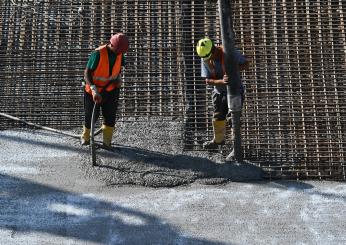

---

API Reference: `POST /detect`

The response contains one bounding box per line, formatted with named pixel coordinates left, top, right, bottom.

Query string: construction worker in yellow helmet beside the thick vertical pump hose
left=196, top=38, right=249, bottom=158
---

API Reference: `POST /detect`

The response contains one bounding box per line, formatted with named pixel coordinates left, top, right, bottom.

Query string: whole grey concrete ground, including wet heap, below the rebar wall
left=0, top=121, right=346, bottom=245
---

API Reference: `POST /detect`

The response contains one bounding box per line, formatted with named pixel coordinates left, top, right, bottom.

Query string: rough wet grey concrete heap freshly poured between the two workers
left=77, top=119, right=262, bottom=187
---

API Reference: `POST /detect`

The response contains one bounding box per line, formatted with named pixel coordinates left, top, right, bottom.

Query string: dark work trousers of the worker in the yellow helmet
left=212, top=91, right=245, bottom=127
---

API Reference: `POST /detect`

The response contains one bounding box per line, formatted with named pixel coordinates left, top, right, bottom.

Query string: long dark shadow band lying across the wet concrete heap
left=99, top=144, right=263, bottom=181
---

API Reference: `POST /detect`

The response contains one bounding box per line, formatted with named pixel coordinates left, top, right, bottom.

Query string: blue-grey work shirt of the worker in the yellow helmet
left=201, top=50, right=246, bottom=94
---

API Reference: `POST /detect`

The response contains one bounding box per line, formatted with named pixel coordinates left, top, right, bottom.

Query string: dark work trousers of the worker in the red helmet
left=84, top=88, right=120, bottom=129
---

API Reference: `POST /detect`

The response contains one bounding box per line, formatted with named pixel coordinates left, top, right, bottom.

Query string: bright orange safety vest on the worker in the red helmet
left=85, top=45, right=122, bottom=94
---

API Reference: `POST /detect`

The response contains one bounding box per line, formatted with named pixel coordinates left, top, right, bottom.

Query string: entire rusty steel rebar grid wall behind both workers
left=0, top=0, right=346, bottom=179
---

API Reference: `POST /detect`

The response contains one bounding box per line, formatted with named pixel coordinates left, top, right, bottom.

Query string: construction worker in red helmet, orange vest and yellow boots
left=81, top=33, right=129, bottom=147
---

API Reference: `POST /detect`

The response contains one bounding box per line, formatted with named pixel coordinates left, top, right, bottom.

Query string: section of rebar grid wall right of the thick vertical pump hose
left=235, top=0, right=346, bottom=179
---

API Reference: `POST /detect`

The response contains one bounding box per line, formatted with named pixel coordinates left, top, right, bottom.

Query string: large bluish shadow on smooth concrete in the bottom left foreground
left=0, top=174, right=228, bottom=245
